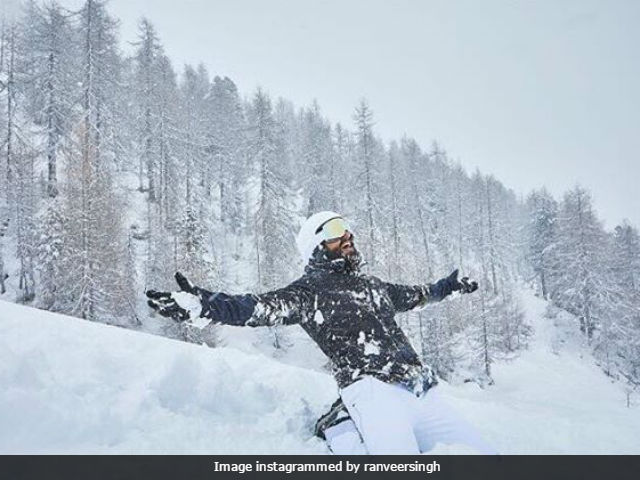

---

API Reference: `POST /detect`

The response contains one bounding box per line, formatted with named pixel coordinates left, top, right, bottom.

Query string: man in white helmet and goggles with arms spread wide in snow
left=147, top=212, right=493, bottom=454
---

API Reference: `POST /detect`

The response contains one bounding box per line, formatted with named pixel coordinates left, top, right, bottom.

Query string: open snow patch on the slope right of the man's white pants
left=442, top=292, right=640, bottom=455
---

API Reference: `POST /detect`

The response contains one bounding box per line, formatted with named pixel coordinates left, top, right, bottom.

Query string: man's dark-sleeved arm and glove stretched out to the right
left=385, top=270, right=478, bottom=312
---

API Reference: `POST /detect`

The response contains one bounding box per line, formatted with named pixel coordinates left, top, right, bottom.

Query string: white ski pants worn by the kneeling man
left=324, top=377, right=497, bottom=455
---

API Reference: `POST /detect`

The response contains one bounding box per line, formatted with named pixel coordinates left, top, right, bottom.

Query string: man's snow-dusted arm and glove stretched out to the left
left=146, top=272, right=311, bottom=327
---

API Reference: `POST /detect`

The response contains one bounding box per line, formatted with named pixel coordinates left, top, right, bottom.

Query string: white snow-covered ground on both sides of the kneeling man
left=0, top=294, right=640, bottom=454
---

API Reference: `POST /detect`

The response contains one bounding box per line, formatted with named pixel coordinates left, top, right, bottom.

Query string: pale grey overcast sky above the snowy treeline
left=1, top=0, right=640, bottom=228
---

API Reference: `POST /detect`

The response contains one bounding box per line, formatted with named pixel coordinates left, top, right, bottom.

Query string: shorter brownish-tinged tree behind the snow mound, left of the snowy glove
left=60, top=125, right=135, bottom=324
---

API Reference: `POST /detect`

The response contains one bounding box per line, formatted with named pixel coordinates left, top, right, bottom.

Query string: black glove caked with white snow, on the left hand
left=145, top=272, right=203, bottom=322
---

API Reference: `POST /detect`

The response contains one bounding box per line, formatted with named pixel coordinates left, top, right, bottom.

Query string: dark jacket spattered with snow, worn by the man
left=201, top=249, right=451, bottom=394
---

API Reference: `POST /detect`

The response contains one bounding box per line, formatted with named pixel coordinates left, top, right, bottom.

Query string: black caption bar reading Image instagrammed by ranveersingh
left=0, top=455, right=640, bottom=480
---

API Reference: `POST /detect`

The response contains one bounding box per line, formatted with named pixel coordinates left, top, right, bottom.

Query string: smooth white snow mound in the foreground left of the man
left=0, top=301, right=337, bottom=454
